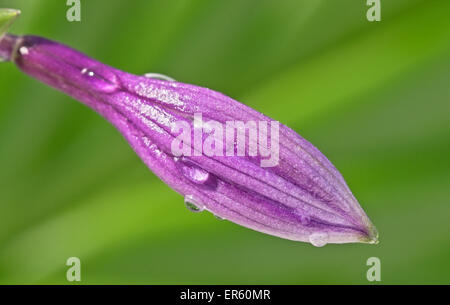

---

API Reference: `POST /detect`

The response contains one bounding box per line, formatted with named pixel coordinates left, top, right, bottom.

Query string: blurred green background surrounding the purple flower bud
left=0, top=0, right=450, bottom=284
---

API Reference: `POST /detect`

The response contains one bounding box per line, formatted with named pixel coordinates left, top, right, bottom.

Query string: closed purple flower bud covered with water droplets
left=0, top=35, right=378, bottom=246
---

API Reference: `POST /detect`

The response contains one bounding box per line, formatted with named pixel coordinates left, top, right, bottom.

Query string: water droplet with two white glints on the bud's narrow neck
left=81, top=67, right=119, bottom=93
